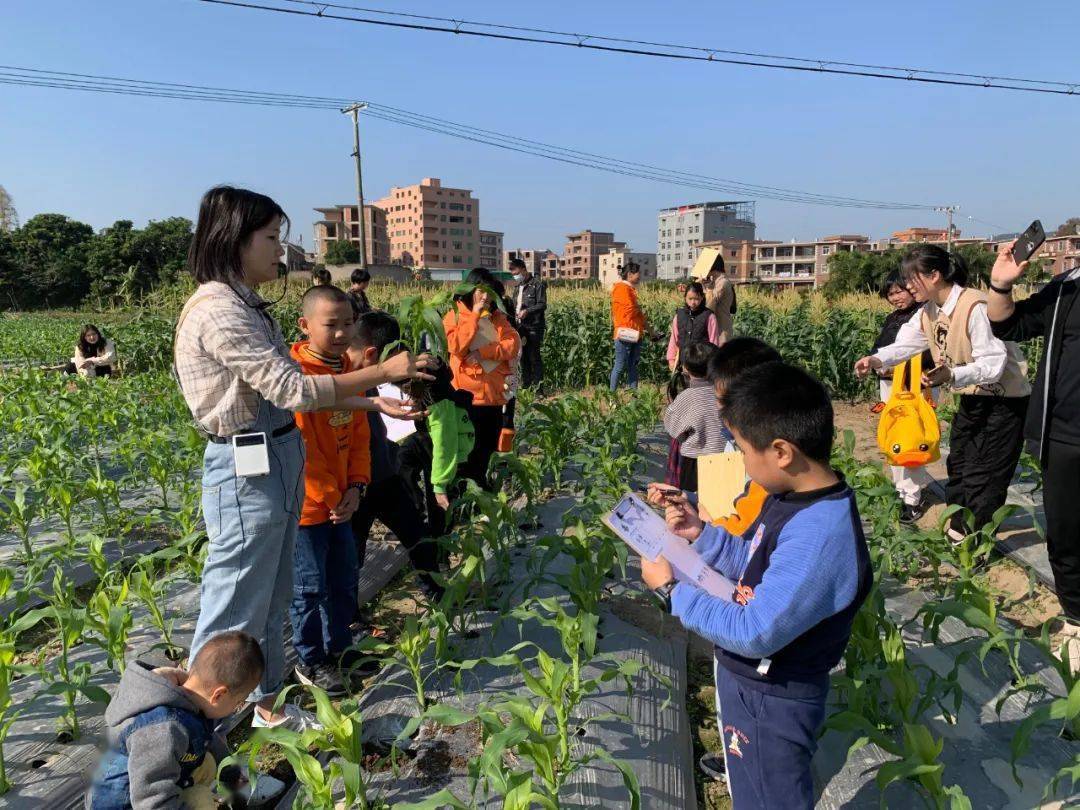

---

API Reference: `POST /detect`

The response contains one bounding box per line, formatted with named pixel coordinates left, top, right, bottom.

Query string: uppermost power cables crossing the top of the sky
left=199, top=0, right=1080, bottom=95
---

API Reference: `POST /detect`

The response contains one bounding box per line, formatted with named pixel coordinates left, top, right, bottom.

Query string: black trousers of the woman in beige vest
left=945, top=394, right=1030, bottom=531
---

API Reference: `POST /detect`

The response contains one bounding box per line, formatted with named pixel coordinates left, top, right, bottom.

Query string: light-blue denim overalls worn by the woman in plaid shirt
left=191, top=402, right=305, bottom=701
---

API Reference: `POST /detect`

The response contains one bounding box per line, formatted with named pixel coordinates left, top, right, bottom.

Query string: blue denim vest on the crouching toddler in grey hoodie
left=87, top=706, right=214, bottom=810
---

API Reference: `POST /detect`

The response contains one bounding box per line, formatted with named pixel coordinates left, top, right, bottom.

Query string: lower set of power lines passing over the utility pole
left=0, top=65, right=932, bottom=211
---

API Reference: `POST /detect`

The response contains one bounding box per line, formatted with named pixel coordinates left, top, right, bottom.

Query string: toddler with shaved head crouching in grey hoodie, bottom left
left=85, top=630, right=265, bottom=810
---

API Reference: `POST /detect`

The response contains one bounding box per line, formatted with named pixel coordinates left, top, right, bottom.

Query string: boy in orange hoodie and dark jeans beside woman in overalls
left=289, top=285, right=372, bottom=697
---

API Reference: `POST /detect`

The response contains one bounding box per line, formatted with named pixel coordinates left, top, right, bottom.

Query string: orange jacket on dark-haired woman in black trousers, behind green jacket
left=443, top=301, right=522, bottom=405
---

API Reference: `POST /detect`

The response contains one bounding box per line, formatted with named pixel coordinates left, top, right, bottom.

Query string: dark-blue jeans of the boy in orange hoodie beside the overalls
left=288, top=522, right=360, bottom=666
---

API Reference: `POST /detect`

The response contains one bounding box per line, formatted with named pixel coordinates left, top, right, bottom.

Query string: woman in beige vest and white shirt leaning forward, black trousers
left=855, top=245, right=1031, bottom=540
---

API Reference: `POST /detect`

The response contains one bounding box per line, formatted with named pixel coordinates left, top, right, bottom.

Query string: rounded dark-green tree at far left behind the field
left=12, top=214, right=94, bottom=307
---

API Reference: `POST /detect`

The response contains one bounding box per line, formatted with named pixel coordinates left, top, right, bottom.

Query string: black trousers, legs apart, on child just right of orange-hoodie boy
left=352, top=475, right=438, bottom=571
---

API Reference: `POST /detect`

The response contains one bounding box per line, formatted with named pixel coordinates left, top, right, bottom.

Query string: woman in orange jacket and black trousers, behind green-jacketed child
left=443, top=268, right=522, bottom=487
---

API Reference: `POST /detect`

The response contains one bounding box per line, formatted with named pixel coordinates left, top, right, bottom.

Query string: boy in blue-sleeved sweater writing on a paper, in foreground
left=642, top=363, right=872, bottom=810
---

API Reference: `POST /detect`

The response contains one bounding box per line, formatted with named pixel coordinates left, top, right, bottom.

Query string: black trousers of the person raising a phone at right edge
left=1042, top=438, right=1080, bottom=622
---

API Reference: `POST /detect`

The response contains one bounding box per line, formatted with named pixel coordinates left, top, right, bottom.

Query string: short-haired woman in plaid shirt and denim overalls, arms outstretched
left=174, top=186, right=428, bottom=731
